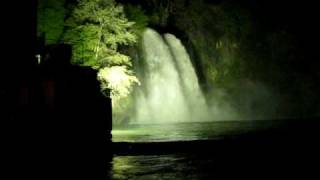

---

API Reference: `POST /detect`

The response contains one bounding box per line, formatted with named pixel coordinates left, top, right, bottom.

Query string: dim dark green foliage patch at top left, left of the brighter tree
left=37, top=0, right=65, bottom=44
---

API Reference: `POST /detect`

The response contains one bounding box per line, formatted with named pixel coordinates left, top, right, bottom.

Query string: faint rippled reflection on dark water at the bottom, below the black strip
left=110, top=154, right=213, bottom=180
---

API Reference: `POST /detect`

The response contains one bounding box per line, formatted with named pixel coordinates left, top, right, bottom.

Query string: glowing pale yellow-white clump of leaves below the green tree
left=98, top=66, right=140, bottom=105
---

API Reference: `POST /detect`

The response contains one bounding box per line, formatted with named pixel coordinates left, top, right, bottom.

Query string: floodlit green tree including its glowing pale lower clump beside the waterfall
left=63, top=0, right=138, bottom=103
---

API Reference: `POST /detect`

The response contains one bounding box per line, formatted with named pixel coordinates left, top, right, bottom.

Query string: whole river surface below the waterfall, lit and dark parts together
left=108, top=121, right=319, bottom=180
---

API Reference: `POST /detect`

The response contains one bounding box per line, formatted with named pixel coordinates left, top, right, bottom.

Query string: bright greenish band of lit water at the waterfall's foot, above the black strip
left=112, top=121, right=279, bottom=142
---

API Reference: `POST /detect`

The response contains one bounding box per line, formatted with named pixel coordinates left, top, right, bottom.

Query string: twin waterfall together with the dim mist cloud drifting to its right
left=115, top=28, right=279, bottom=124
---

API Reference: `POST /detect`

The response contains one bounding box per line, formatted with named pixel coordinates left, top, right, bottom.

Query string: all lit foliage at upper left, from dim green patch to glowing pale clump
left=38, top=0, right=139, bottom=104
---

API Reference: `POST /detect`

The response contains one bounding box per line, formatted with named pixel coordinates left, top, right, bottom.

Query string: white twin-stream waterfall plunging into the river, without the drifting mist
left=134, top=29, right=207, bottom=123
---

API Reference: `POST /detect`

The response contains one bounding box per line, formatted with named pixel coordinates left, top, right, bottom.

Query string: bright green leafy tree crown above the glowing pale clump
left=64, top=0, right=136, bottom=69
